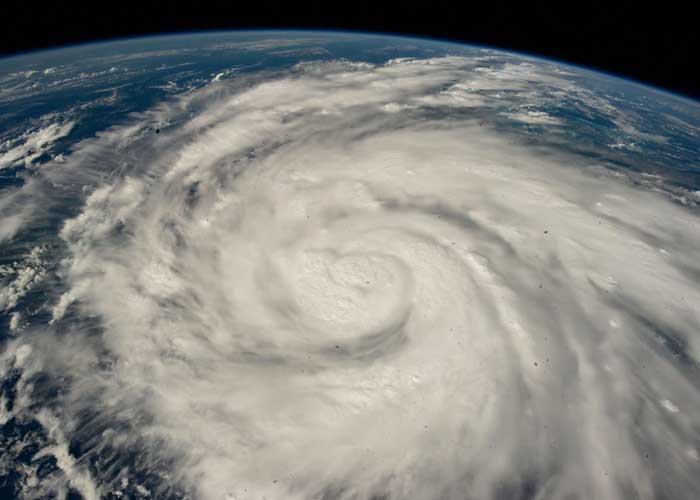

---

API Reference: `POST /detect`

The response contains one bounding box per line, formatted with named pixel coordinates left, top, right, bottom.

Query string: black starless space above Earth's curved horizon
left=5, top=0, right=700, bottom=98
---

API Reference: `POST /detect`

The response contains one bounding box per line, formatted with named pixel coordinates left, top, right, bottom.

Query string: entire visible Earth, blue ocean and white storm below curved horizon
left=0, top=32, right=700, bottom=500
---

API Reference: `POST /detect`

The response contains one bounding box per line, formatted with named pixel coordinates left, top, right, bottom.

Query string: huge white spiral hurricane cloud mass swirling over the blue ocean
left=4, top=57, right=700, bottom=500
